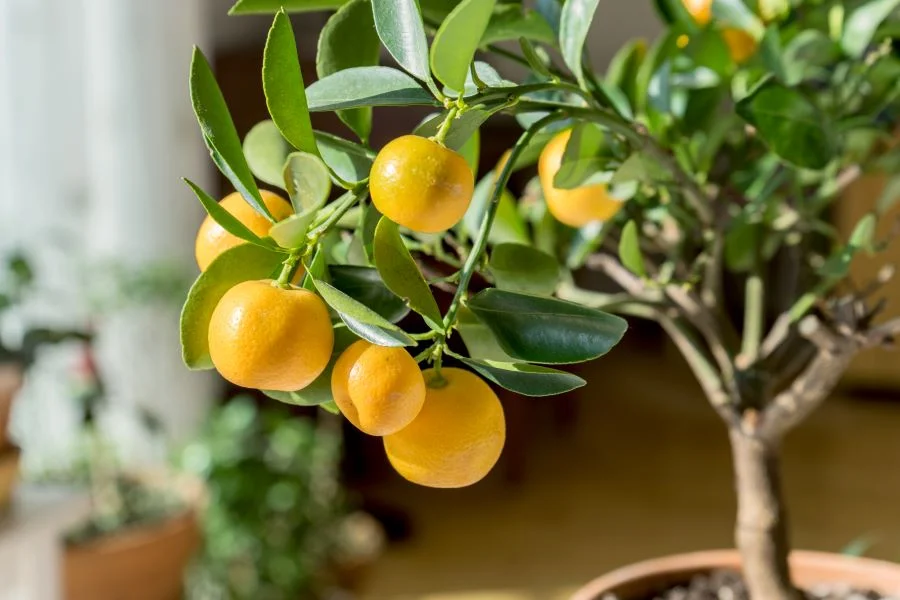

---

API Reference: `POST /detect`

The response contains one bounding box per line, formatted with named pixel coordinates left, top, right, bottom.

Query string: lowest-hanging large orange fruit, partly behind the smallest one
left=384, top=368, right=506, bottom=488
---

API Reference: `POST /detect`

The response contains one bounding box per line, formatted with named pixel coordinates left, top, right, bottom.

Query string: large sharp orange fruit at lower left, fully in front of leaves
left=208, top=280, right=334, bottom=392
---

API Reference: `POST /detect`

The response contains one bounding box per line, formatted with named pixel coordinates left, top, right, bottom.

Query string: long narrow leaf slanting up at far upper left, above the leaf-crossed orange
left=190, top=47, right=275, bottom=221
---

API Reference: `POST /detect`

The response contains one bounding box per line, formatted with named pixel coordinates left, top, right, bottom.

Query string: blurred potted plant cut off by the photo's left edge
left=0, top=253, right=86, bottom=511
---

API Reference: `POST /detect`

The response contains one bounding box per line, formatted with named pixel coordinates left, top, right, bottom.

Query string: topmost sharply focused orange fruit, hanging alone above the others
left=369, top=135, right=475, bottom=233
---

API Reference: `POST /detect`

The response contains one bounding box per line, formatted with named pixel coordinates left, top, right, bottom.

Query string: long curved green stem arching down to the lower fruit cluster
left=444, top=112, right=566, bottom=337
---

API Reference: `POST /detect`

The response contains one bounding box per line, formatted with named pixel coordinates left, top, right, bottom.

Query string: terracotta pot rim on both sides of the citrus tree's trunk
left=572, top=550, right=900, bottom=600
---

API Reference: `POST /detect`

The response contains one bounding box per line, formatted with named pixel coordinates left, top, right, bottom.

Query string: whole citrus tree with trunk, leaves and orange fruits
left=182, top=0, right=900, bottom=600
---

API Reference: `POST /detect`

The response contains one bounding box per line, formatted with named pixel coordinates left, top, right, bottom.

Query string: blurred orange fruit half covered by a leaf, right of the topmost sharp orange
left=538, top=130, right=622, bottom=227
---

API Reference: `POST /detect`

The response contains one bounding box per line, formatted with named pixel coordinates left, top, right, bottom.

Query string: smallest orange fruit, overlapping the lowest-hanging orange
left=331, top=340, right=425, bottom=435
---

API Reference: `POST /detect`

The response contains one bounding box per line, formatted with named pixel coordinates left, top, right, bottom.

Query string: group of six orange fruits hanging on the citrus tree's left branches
left=196, top=132, right=619, bottom=488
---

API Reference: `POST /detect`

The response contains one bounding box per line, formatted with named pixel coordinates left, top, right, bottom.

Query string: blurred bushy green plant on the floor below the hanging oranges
left=181, top=397, right=383, bottom=600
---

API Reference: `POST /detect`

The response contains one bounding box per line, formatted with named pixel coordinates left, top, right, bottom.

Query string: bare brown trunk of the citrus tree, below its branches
left=730, top=429, right=800, bottom=600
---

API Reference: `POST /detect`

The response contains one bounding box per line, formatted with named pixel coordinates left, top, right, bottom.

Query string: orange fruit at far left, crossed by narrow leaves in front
left=194, top=190, right=294, bottom=271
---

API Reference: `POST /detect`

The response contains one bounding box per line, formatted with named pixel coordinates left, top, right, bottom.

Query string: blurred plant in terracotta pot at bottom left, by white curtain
left=55, top=342, right=203, bottom=600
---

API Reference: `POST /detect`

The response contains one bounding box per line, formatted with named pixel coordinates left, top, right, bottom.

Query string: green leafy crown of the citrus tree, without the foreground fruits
left=192, top=0, right=900, bottom=426
